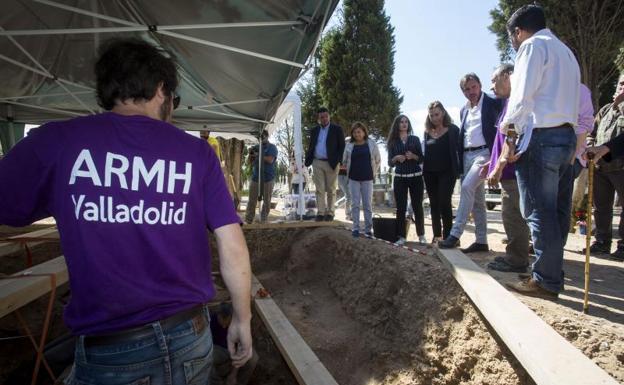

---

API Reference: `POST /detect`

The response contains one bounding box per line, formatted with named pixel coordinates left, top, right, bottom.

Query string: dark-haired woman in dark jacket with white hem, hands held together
left=387, top=115, right=425, bottom=245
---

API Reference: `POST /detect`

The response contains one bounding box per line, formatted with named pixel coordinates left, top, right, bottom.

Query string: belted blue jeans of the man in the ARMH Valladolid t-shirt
left=65, top=307, right=213, bottom=385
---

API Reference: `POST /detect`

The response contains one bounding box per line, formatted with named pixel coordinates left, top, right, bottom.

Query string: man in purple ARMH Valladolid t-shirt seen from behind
left=0, top=39, right=252, bottom=384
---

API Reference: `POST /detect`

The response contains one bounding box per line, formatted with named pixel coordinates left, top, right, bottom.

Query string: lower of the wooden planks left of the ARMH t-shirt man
left=0, top=256, right=68, bottom=318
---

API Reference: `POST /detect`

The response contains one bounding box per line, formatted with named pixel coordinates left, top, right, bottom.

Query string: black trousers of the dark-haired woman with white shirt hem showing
left=393, top=176, right=425, bottom=238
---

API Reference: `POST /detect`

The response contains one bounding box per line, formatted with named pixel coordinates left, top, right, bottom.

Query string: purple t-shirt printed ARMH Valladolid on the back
left=0, top=112, right=240, bottom=335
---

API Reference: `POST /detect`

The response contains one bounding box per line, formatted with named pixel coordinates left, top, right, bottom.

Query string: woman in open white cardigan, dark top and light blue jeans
left=342, top=122, right=381, bottom=238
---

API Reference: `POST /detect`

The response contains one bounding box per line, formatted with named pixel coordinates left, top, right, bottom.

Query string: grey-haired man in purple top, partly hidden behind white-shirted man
left=488, top=64, right=530, bottom=273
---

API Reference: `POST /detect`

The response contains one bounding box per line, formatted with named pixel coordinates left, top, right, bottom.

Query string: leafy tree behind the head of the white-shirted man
left=489, top=0, right=624, bottom=106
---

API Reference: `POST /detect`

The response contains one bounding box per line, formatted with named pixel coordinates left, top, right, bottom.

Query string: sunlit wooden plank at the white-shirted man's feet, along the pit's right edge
left=437, top=249, right=618, bottom=385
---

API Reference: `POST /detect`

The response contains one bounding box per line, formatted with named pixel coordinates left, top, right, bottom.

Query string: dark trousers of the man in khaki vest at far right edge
left=594, top=170, right=624, bottom=247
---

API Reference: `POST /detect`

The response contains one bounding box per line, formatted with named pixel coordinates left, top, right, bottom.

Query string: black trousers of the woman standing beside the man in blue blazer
left=423, top=170, right=456, bottom=239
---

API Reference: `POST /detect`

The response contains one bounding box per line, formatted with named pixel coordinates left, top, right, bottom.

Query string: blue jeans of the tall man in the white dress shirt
left=516, top=127, right=576, bottom=293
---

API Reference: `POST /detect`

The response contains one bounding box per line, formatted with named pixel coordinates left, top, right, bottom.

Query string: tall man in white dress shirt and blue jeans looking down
left=501, top=5, right=580, bottom=299
